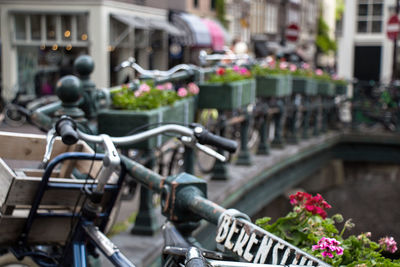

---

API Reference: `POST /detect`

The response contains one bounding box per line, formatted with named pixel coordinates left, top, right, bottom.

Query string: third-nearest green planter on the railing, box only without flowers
left=256, top=75, right=292, bottom=97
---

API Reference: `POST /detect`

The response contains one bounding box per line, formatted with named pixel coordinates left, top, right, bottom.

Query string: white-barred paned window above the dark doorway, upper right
left=357, top=0, right=383, bottom=33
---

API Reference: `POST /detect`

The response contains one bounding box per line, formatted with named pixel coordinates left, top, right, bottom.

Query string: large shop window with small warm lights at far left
left=12, top=13, right=88, bottom=96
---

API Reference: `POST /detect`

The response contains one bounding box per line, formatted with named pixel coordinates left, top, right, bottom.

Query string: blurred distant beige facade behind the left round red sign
left=242, top=0, right=319, bottom=62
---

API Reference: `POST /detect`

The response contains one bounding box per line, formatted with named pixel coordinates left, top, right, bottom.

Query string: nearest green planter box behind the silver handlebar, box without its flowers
left=97, top=97, right=195, bottom=149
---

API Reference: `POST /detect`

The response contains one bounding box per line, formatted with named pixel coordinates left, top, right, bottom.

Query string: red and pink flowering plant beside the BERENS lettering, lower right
left=256, top=192, right=400, bottom=267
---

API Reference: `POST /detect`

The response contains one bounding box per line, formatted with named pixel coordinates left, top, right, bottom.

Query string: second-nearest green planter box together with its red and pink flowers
left=197, top=66, right=255, bottom=110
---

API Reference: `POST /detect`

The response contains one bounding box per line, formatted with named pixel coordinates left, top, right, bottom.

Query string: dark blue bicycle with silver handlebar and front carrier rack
left=0, top=117, right=236, bottom=266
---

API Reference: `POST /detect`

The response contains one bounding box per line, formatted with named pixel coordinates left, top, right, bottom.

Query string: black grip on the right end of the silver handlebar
left=194, top=127, right=238, bottom=153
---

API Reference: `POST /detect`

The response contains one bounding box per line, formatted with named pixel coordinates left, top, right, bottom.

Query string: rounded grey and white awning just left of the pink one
left=171, top=13, right=212, bottom=47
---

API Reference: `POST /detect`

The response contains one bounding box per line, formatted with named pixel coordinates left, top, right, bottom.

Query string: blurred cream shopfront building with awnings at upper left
left=0, top=0, right=229, bottom=100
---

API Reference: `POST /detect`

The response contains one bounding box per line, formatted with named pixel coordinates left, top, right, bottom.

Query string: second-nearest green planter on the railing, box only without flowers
left=197, top=79, right=256, bottom=110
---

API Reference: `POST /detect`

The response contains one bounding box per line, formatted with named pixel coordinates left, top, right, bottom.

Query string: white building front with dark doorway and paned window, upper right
left=338, top=0, right=398, bottom=82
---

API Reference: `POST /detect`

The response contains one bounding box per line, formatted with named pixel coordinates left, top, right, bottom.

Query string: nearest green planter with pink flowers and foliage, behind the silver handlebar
left=98, top=82, right=199, bottom=149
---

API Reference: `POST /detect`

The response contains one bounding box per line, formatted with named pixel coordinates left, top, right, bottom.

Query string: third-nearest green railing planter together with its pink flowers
left=253, top=61, right=292, bottom=97
